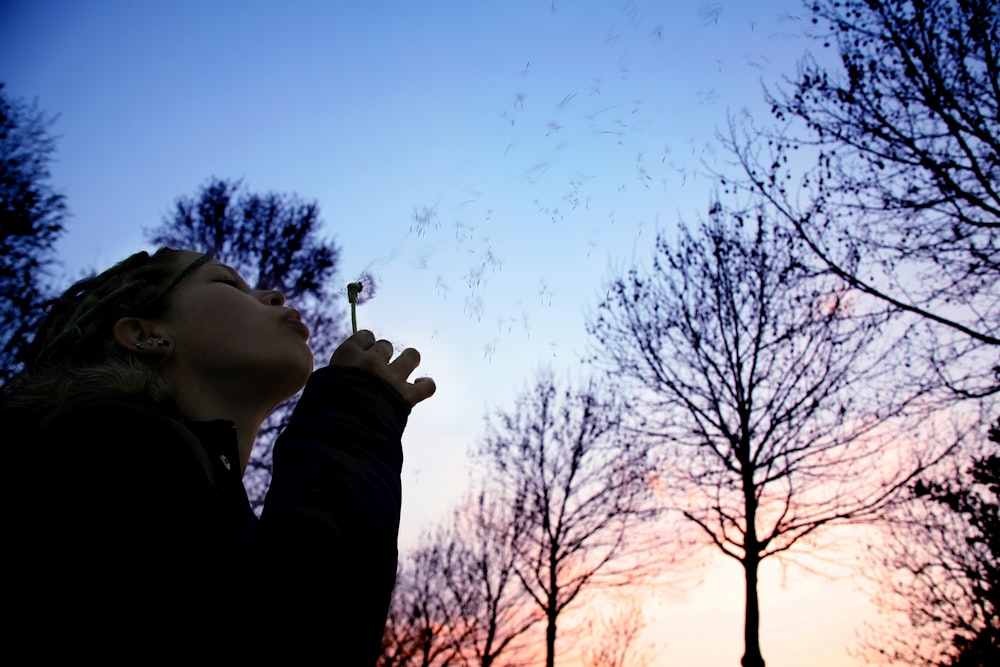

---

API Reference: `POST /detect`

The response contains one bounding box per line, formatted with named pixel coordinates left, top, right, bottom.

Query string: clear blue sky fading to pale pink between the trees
left=0, top=0, right=884, bottom=667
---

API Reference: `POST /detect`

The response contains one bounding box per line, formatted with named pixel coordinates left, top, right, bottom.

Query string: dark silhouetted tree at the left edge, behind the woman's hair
left=0, top=84, right=67, bottom=386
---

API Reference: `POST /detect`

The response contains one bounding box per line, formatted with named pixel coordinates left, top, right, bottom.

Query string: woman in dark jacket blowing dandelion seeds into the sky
left=0, top=248, right=435, bottom=665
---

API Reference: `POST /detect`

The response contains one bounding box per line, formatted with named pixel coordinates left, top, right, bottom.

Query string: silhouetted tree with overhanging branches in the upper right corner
left=731, top=0, right=1000, bottom=396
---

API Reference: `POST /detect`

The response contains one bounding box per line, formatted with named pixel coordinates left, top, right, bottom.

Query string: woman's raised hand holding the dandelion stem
left=330, top=329, right=437, bottom=407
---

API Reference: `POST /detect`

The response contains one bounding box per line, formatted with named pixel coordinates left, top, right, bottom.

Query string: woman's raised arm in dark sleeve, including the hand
left=261, top=332, right=433, bottom=665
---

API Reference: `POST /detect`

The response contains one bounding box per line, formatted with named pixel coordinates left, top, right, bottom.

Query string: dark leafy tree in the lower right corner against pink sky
left=863, top=420, right=1000, bottom=667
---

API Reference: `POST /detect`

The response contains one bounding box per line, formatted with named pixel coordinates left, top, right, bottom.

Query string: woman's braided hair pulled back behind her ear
left=0, top=248, right=203, bottom=416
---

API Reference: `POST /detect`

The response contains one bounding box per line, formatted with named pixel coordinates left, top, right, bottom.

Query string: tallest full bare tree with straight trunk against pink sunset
left=588, top=203, right=948, bottom=667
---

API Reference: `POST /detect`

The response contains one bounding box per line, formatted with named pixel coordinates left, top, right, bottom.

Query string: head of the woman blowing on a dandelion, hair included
left=3, top=248, right=312, bottom=420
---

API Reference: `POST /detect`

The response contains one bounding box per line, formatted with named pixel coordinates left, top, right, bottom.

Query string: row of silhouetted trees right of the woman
left=382, top=0, right=1000, bottom=667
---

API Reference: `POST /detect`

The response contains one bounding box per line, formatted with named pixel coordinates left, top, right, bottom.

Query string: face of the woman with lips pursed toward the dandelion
left=158, top=251, right=313, bottom=407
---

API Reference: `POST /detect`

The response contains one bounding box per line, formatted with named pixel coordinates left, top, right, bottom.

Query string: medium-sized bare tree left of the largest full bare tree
left=479, top=373, right=652, bottom=667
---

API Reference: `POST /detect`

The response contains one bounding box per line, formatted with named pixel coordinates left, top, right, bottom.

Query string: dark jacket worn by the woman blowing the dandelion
left=0, top=367, right=409, bottom=665
